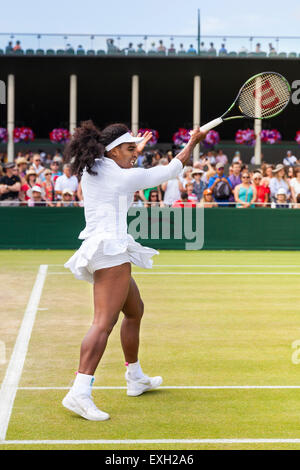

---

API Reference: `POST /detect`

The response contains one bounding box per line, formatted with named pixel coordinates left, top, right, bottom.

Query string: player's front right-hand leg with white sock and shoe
left=121, top=278, right=162, bottom=396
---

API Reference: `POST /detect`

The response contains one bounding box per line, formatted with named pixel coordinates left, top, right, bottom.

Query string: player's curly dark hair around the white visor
left=64, top=120, right=129, bottom=176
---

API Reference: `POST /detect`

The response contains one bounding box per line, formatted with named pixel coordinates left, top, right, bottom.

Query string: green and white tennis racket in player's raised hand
left=200, top=72, right=291, bottom=132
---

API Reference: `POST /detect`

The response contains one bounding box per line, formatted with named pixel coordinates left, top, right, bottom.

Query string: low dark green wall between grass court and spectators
left=0, top=207, right=300, bottom=250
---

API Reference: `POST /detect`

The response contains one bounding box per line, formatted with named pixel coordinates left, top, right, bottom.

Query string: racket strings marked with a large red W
left=238, top=73, right=290, bottom=118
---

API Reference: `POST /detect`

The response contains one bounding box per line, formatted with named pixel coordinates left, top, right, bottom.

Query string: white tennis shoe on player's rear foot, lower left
left=62, top=390, right=110, bottom=421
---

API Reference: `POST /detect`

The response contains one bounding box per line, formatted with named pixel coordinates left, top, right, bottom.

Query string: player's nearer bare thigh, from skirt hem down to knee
left=94, top=263, right=131, bottom=325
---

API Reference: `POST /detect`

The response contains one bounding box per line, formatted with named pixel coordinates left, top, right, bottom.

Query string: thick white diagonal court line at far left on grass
left=0, top=264, right=48, bottom=441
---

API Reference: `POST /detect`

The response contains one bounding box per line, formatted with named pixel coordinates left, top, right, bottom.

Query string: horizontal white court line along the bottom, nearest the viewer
left=0, top=438, right=300, bottom=445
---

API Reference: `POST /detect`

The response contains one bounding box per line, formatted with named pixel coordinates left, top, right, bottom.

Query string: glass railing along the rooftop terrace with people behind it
left=0, top=33, right=300, bottom=57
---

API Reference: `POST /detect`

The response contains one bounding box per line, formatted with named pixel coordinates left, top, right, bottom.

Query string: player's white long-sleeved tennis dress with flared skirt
left=64, top=157, right=183, bottom=283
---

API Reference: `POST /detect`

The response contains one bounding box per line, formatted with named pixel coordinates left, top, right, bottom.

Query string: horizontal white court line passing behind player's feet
left=18, top=385, right=300, bottom=390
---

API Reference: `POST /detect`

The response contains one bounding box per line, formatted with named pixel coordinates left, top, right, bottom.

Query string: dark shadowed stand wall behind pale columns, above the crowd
left=0, top=55, right=300, bottom=142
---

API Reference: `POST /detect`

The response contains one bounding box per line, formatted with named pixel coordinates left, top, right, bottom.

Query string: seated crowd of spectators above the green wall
left=0, top=145, right=300, bottom=209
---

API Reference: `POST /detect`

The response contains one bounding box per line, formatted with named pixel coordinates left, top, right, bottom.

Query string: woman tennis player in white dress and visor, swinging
left=62, top=121, right=206, bottom=421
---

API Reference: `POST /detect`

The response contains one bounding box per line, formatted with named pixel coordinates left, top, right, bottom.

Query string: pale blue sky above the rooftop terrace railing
left=0, top=0, right=300, bottom=36
